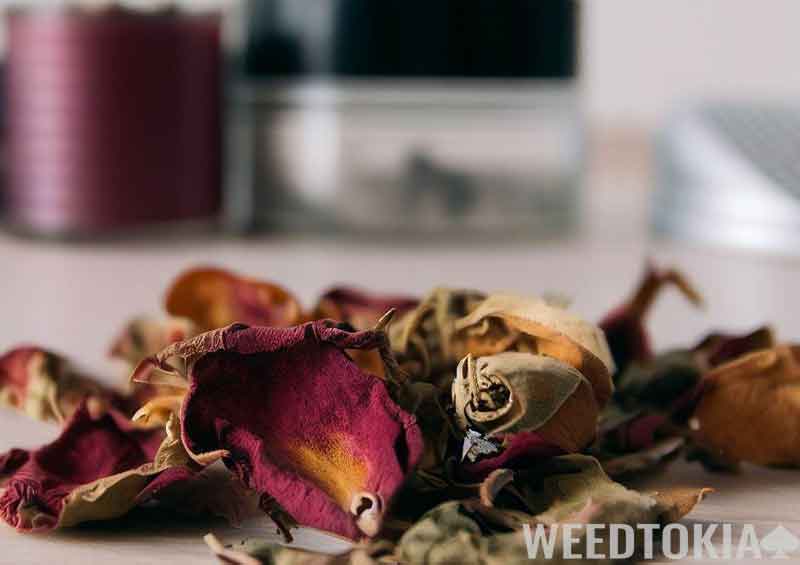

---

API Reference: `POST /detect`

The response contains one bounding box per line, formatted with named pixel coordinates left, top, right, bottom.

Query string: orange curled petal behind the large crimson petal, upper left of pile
left=166, top=268, right=305, bottom=331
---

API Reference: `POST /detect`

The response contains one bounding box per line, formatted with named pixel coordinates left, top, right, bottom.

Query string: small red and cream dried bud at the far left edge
left=0, top=346, right=127, bottom=422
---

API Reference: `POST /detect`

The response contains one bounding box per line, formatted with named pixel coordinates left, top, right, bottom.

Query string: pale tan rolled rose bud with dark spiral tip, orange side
left=452, top=352, right=598, bottom=479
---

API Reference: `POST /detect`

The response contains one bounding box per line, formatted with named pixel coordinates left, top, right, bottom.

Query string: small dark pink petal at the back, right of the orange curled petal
left=311, top=286, right=419, bottom=330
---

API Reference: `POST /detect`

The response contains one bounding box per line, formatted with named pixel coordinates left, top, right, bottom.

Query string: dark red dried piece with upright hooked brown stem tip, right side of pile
left=600, top=264, right=703, bottom=371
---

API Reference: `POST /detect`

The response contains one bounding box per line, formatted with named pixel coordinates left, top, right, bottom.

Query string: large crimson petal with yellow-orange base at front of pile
left=137, top=320, right=423, bottom=538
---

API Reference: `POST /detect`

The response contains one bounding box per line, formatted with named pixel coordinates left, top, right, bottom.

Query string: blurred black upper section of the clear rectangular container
left=244, top=0, right=578, bottom=78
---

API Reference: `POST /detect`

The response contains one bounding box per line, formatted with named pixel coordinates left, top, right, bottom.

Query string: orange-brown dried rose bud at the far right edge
left=690, top=345, right=800, bottom=466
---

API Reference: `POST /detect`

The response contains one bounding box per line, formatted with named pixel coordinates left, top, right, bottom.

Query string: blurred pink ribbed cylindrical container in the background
left=4, top=9, right=221, bottom=236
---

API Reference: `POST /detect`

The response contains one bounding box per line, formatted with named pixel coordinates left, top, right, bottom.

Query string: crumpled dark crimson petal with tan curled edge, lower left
left=0, top=403, right=199, bottom=532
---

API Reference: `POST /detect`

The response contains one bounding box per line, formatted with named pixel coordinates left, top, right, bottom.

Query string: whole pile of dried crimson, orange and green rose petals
left=0, top=266, right=800, bottom=564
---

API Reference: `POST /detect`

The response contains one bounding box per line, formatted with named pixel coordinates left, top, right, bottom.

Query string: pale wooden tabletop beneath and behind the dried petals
left=0, top=134, right=800, bottom=565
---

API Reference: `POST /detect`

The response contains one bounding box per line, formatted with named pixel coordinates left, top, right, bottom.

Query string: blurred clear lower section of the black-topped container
left=228, top=79, right=583, bottom=237
